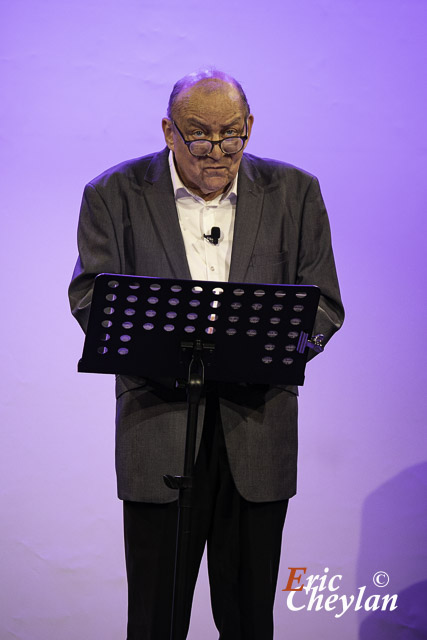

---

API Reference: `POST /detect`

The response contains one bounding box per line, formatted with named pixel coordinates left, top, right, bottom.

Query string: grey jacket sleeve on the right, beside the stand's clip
left=297, top=177, right=344, bottom=359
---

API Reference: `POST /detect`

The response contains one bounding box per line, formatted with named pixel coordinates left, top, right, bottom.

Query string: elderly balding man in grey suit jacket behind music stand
left=70, top=71, right=344, bottom=640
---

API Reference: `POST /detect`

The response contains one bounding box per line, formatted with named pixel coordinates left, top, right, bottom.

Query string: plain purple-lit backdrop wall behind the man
left=0, top=0, right=427, bottom=640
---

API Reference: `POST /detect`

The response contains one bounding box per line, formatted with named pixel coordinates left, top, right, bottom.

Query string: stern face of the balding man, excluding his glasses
left=162, top=80, right=253, bottom=200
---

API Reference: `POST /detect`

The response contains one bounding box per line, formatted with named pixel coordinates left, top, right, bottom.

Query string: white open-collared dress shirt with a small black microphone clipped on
left=169, top=151, right=237, bottom=282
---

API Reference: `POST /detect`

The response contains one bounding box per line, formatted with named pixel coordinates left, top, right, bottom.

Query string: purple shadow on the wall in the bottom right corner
left=357, top=463, right=427, bottom=640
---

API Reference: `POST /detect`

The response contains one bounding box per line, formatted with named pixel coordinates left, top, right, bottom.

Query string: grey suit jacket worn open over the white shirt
left=69, top=149, right=344, bottom=502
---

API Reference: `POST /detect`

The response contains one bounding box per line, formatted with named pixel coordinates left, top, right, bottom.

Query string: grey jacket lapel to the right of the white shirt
left=228, top=156, right=264, bottom=282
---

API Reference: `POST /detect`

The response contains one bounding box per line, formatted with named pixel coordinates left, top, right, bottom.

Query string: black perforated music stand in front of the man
left=78, top=274, right=323, bottom=640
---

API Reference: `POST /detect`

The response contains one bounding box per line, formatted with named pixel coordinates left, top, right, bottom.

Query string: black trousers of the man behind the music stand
left=124, top=394, right=288, bottom=640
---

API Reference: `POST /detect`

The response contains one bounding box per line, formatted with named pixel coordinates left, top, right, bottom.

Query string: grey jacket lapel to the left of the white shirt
left=143, top=149, right=191, bottom=280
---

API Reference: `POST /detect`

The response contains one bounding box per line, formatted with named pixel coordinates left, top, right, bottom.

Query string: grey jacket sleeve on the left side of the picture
left=68, top=183, right=122, bottom=332
